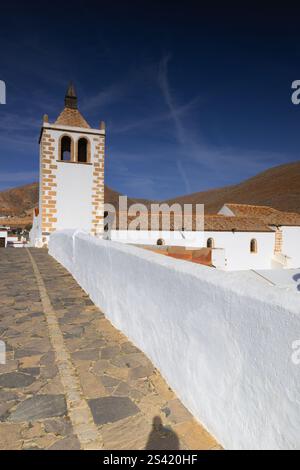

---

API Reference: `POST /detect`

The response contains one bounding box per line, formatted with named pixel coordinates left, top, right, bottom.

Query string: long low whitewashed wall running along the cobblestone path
left=49, top=232, right=300, bottom=449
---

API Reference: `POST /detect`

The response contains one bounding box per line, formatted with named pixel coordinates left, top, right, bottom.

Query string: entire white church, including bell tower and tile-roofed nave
left=30, top=85, right=300, bottom=270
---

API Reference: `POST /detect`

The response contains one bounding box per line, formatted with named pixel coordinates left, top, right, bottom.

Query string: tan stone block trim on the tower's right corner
left=91, top=136, right=105, bottom=236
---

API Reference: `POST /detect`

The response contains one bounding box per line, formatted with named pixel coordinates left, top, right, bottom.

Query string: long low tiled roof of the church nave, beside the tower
left=108, top=214, right=273, bottom=232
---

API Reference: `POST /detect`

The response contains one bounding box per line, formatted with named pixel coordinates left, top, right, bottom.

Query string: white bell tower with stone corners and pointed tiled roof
left=33, top=83, right=105, bottom=245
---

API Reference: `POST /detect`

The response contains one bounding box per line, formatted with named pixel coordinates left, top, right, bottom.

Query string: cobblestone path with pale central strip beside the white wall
left=0, top=248, right=220, bottom=450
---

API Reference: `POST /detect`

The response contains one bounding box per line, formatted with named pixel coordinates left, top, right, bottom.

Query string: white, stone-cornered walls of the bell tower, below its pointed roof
left=30, top=123, right=105, bottom=247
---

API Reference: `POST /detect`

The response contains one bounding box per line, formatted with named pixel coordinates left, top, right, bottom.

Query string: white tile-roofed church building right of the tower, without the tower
left=107, top=204, right=300, bottom=271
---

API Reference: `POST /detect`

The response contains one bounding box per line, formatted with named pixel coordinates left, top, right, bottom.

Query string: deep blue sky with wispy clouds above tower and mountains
left=0, top=0, right=300, bottom=199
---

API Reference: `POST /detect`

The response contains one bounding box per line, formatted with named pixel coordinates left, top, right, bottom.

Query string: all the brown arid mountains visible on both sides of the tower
left=0, top=162, right=300, bottom=222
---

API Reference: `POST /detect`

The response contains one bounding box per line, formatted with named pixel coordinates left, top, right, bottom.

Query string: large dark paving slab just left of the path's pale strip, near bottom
left=8, top=395, right=67, bottom=422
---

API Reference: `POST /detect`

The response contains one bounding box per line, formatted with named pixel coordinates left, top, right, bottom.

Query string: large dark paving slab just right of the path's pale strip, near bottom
left=89, top=397, right=140, bottom=425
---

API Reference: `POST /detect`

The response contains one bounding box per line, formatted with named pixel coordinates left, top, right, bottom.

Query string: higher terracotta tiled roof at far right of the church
left=225, top=204, right=300, bottom=226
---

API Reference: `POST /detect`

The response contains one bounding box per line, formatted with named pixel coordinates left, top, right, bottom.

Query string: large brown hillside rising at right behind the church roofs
left=166, top=162, right=300, bottom=214
